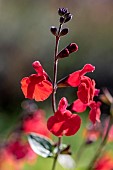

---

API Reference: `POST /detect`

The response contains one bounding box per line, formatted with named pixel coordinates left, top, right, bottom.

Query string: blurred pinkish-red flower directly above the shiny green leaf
left=23, top=110, right=50, bottom=137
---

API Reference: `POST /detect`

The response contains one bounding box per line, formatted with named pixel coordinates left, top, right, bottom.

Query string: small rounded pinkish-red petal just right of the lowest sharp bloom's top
left=71, top=99, right=87, bottom=113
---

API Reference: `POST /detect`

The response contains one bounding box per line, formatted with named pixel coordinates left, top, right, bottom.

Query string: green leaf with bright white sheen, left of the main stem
left=28, top=133, right=53, bottom=158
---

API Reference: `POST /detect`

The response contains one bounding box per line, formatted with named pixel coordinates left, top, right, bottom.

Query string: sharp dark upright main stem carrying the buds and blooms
left=52, top=24, right=62, bottom=170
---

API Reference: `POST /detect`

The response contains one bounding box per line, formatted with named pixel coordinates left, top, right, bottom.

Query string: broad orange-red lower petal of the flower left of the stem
left=21, top=74, right=52, bottom=101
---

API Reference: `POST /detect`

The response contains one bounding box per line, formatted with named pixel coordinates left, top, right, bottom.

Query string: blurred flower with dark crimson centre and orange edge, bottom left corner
left=0, top=139, right=37, bottom=170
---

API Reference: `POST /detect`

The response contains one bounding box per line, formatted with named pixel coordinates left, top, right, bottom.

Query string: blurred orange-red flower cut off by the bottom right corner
left=94, top=153, right=113, bottom=170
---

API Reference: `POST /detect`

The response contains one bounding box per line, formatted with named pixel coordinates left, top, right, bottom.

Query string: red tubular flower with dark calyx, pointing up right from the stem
left=58, top=64, right=95, bottom=87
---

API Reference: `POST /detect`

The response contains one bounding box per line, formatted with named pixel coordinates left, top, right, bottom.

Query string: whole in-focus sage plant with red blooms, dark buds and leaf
left=21, top=8, right=100, bottom=170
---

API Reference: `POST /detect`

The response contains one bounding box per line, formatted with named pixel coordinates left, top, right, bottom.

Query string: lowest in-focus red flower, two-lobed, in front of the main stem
left=47, top=97, right=81, bottom=137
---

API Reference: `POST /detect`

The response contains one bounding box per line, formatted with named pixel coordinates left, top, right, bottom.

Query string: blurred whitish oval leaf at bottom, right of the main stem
left=58, top=154, right=76, bottom=169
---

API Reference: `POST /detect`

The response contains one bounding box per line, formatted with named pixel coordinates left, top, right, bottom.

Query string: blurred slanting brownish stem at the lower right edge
left=87, top=115, right=113, bottom=170
